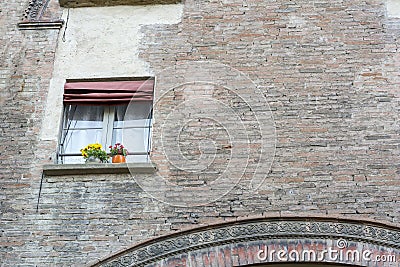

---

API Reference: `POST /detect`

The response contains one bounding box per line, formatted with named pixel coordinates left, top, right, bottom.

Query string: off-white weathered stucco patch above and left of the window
left=41, top=4, right=183, bottom=140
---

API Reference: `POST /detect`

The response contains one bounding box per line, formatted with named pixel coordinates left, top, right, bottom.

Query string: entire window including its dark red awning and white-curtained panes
left=57, top=79, right=154, bottom=164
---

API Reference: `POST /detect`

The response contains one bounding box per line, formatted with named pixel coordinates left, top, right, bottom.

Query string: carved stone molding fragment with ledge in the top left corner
left=18, top=0, right=63, bottom=30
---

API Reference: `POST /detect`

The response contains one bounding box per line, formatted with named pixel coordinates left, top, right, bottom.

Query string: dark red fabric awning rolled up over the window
left=64, top=79, right=154, bottom=105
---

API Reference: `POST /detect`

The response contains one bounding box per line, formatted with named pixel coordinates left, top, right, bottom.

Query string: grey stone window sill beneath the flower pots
left=43, top=163, right=156, bottom=176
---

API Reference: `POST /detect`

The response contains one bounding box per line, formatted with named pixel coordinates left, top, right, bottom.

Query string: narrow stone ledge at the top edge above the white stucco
left=59, top=0, right=182, bottom=7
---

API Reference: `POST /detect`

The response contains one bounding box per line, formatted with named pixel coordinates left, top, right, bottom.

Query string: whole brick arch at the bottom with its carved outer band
left=93, top=218, right=400, bottom=267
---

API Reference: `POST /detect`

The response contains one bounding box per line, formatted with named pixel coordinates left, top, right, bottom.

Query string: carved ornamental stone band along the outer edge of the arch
left=90, top=218, right=400, bottom=267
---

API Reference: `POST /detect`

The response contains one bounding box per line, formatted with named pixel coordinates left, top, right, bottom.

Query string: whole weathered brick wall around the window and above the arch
left=0, top=0, right=400, bottom=266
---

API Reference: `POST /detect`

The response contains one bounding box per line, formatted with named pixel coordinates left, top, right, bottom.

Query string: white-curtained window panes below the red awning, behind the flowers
left=58, top=101, right=152, bottom=163
